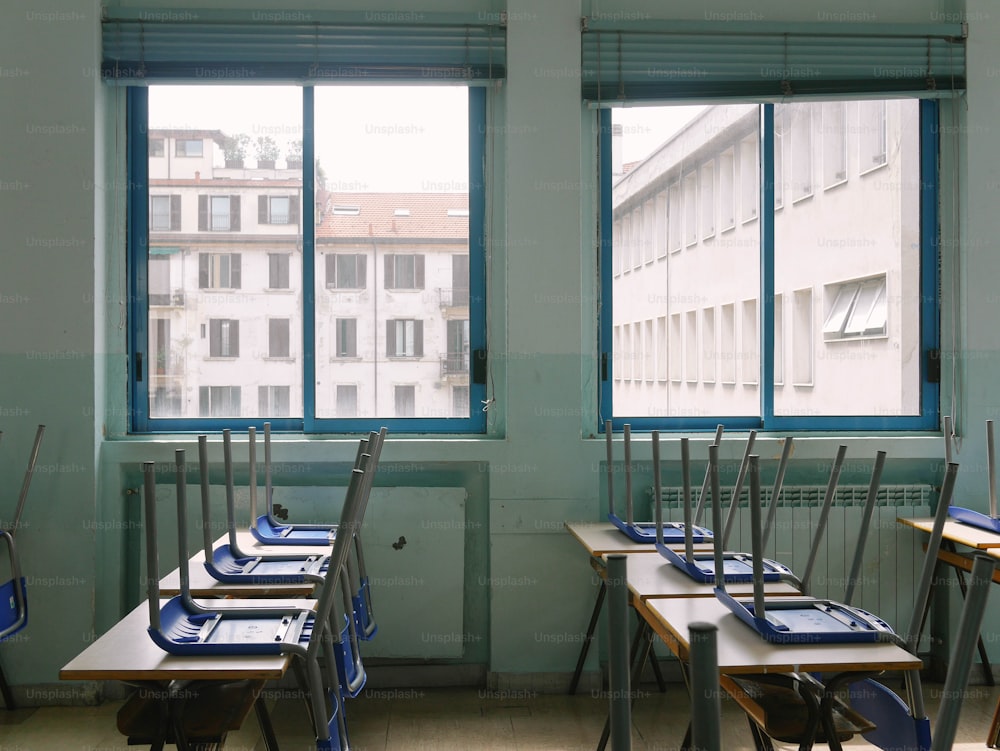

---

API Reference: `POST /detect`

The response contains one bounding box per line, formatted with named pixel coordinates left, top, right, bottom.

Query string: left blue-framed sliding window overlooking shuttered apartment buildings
left=126, top=82, right=490, bottom=433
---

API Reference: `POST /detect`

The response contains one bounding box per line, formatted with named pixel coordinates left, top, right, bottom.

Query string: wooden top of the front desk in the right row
left=636, top=597, right=922, bottom=675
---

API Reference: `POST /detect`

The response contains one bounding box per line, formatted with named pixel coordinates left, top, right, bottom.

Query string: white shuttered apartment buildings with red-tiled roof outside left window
left=147, top=130, right=469, bottom=418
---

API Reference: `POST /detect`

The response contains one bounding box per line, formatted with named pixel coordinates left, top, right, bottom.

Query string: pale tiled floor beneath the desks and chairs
left=0, top=684, right=1000, bottom=751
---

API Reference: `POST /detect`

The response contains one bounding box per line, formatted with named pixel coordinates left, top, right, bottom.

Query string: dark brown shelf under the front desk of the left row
left=118, top=680, right=264, bottom=744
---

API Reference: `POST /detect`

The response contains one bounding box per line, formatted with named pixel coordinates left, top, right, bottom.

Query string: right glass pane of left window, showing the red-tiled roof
left=315, top=85, right=470, bottom=418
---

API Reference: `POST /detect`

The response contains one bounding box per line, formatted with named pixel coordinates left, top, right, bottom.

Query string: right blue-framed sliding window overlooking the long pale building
left=597, top=97, right=940, bottom=431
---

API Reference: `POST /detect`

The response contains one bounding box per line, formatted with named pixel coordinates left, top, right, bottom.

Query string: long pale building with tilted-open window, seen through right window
left=612, top=100, right=920, bottom=416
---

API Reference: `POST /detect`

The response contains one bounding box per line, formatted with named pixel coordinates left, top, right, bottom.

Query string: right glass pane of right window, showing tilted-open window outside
left=774, top=100, right=921, bottom=416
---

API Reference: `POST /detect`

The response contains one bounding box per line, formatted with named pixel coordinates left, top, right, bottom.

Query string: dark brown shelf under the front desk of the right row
left=720, top=675, right=875, bottom=743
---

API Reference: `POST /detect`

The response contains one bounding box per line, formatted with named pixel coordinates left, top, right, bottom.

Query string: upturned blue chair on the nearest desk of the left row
left=143, top=450, right=371, bottom=751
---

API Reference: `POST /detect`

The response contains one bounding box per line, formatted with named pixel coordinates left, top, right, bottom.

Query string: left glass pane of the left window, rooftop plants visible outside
left=148, top=85, right=302, bottom=418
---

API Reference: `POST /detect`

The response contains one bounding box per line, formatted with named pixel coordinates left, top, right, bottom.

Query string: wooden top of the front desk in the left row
left=59, top=600, right=314, bottom=682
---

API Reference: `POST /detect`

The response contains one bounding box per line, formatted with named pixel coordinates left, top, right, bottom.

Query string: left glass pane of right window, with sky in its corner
left=611, top=105, right=760, bottom=417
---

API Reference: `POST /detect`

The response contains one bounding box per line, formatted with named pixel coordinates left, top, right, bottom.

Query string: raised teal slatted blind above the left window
left=102, top=11, right=506, bottom=82
